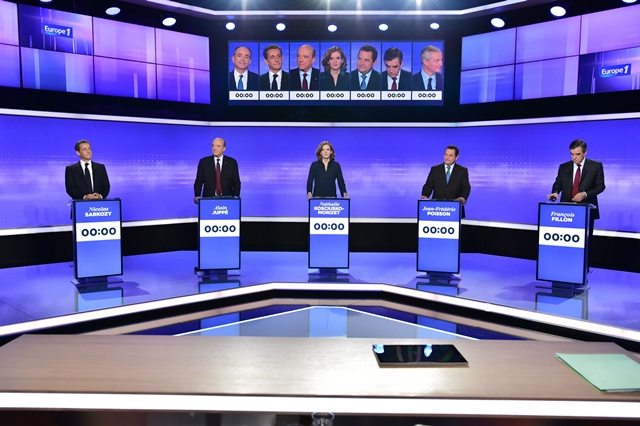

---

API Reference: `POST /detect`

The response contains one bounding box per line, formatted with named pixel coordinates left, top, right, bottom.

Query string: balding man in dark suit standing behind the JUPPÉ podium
left=193, top=138, right=240, bottom=204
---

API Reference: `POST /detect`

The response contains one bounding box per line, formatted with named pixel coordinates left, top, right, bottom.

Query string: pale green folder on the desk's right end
left=556, top=354, right=640, bottom=392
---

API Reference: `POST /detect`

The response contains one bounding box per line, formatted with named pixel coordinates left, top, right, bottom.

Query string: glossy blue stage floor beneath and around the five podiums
left=0, top=251, right=640, bottom=330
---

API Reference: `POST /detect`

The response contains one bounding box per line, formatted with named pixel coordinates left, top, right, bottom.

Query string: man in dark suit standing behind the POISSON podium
left=421, top=145, right=471, bottom=218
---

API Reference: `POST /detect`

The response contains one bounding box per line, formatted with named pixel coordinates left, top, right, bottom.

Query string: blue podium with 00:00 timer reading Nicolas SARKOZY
left=71, top=198, right=122, bottom=284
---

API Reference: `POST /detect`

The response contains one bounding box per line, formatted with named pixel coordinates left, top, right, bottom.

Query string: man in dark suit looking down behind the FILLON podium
left=547, top=139, right=605, bottom=235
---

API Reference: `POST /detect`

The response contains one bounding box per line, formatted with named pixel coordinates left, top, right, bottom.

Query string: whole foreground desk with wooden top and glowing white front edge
left=0, top=335, right=640, bottom=426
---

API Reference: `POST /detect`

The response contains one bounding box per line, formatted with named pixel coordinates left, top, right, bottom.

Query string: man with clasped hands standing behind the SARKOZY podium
left=64, top=139, right=111, bottom=200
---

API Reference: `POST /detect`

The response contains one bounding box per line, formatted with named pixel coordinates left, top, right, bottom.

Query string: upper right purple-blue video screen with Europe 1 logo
left=460, top=6, right=640, bottom=104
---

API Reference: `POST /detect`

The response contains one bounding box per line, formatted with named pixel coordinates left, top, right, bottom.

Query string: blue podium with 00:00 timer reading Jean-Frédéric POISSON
left=416, top=199, right=462, bottom=279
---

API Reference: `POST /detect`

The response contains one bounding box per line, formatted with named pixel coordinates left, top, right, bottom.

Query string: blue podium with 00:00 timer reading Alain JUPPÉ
left=197, top=197, right=241, bottom=275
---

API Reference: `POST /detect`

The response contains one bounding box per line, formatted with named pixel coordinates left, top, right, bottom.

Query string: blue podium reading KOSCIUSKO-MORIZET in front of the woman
left=309, top=198, right=350, bottom=273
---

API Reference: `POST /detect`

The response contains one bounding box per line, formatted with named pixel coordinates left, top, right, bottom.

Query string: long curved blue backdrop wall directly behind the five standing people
left=0, top=115, right=640, bottom=232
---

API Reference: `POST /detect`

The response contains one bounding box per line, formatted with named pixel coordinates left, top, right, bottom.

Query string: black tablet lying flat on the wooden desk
left=373, top=345, right=469, bottom=367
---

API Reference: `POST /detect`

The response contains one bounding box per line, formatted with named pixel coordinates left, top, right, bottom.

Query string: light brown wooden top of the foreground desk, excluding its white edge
left=0, top=335, right=640, bottom=417
